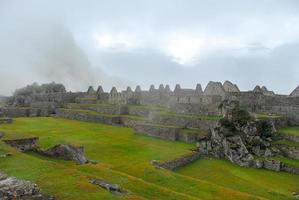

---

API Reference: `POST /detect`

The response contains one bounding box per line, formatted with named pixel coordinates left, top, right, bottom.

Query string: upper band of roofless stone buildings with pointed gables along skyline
left=0, top=81, right=299, bottom=123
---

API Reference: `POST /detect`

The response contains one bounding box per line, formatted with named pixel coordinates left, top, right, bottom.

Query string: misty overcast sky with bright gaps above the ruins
left=0, top=0, right=299, bottom=95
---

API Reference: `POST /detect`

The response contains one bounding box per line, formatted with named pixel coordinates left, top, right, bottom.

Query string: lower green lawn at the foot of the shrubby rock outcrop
left=177, top=158, right=299, bottom=199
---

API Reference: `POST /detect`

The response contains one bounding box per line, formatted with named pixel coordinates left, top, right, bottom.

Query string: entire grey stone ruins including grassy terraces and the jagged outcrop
left=0, top=81, right=299, bottom=174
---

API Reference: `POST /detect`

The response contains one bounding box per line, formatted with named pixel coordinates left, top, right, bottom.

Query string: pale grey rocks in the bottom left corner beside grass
left=0, top=172, right=55, bottom=200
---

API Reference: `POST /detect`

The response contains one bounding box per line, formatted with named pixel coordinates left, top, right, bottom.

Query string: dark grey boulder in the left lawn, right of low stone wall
left=41, top=144, right=88, bottom=164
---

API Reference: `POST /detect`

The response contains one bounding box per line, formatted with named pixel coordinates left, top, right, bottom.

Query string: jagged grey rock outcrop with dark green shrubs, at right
left=198, top=102, right=299, bottom=174
